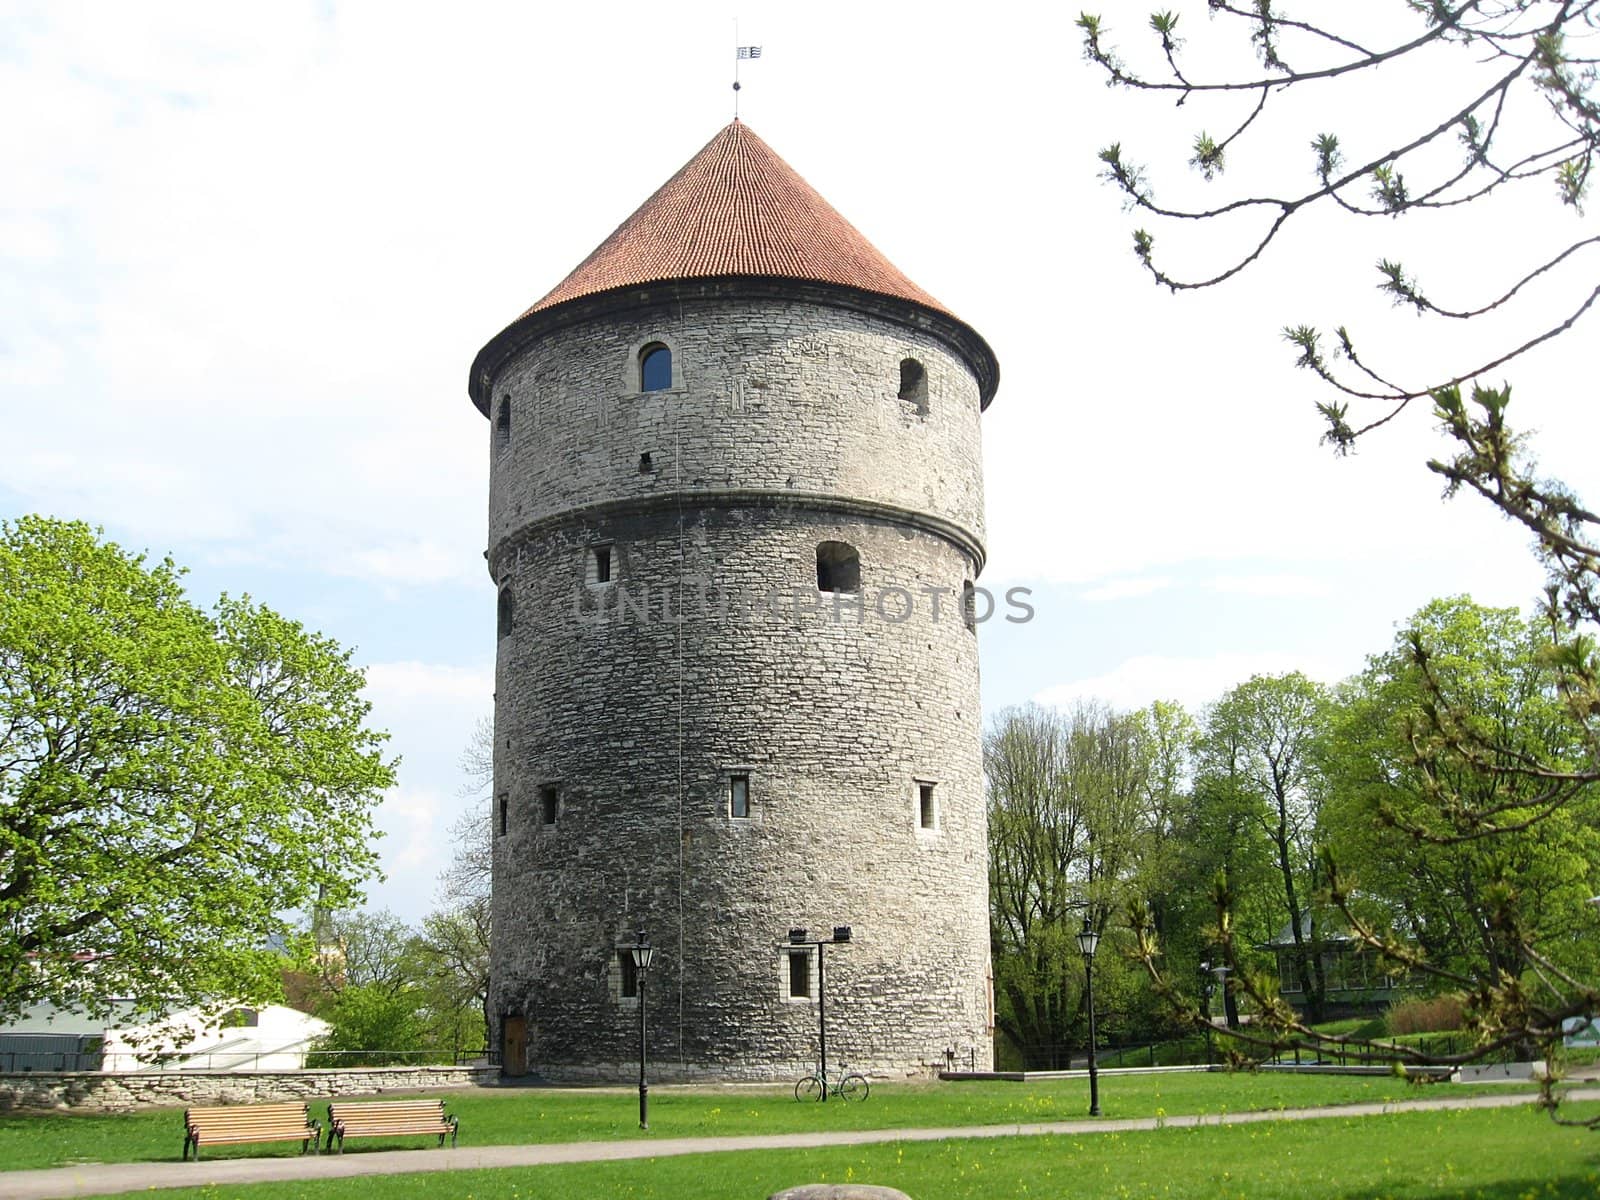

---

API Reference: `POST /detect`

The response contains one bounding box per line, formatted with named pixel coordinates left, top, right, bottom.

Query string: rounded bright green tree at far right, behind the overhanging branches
left=1328, top=597, right=1600, bottom=1042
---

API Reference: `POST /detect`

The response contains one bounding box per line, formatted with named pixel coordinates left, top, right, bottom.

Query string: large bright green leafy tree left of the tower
left=0, top=517, right=394, bottom=1018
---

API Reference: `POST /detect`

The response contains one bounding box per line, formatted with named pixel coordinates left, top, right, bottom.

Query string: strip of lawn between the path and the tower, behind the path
left=0, top=1072, right=1531, bottom=1170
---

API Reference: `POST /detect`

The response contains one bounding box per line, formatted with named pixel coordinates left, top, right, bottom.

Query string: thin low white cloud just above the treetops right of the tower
left=1034, top=653, right=1360, bottom=709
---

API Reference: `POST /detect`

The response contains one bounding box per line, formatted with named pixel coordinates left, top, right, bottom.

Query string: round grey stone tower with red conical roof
left=469, top=122, right=998, bottom=1078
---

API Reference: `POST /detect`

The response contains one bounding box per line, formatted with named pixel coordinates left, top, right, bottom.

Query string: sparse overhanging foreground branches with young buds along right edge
left=1078, top=0, right=1600, bottom=1122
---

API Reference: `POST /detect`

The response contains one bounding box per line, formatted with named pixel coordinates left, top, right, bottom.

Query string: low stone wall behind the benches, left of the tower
left=0, top=1067, right=499, bottom=1112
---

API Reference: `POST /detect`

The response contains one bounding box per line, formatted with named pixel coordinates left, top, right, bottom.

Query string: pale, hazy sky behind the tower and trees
left=0, top=0, right=1600, bottom=920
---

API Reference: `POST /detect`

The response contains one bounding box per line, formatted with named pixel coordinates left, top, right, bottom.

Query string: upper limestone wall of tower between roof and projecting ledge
left=488, top=301, right=982, bottom=547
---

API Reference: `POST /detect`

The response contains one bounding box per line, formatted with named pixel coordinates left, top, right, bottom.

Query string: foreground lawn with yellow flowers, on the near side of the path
left=68, top=1106, right=1600, bottom=1200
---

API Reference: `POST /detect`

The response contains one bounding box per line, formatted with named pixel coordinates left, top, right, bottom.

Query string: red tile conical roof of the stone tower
left=523, top=120, right=952, bottom=317
